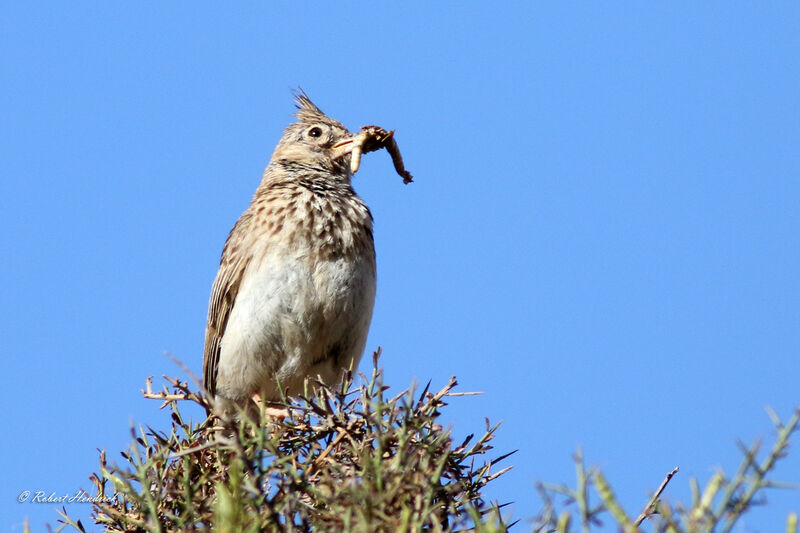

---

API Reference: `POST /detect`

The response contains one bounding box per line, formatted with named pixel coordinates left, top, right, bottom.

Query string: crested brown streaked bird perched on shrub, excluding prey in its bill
left=203, top=90, right=376, bottom=412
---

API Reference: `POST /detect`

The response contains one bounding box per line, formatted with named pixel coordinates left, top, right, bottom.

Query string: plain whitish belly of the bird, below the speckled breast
left=212, top=252, right=375, bottom=400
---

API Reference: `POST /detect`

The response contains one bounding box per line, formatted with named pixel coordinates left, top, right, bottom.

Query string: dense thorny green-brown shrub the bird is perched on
left=62, top=353, right=510, bottom=532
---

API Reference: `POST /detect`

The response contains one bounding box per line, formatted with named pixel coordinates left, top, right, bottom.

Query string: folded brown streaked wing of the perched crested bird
left=203, top=212, right=251, bottom=398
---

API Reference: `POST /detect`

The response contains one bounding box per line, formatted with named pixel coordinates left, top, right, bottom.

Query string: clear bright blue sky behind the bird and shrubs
left=0, top=2, right=800, bottom=531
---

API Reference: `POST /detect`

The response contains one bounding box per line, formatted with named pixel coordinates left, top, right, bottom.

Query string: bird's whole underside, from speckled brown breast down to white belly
left=218, top=185, right=376, bottom=399
